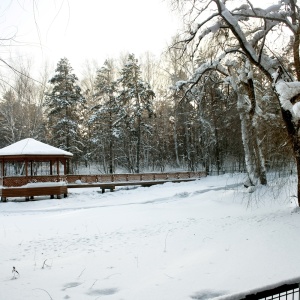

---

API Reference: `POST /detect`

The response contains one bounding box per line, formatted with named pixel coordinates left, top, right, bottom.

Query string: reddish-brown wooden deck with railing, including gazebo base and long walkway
left=0, top=172, right=206, bottom=202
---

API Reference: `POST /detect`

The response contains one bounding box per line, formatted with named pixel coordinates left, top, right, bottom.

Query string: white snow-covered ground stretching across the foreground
left=0, top=175, right=300, bottom=300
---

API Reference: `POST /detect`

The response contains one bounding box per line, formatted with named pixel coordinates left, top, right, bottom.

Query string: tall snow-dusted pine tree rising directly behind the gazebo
left=45, top=58, right=85, bottom=172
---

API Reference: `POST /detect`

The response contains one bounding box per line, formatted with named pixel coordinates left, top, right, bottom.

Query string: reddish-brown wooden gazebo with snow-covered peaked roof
left=0, top=138, right=73, bottom=201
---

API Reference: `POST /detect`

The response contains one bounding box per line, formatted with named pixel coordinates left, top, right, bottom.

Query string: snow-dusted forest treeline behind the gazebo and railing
left=0, top=40, right=292, bottom=174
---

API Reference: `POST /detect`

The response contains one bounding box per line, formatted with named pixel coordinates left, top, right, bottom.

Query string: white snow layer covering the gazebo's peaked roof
left=0, top=138, right=73, bottom=156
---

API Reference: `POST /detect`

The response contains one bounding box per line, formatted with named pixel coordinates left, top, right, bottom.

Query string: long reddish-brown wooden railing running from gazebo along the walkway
left=0, top=172, right=206, bottom=187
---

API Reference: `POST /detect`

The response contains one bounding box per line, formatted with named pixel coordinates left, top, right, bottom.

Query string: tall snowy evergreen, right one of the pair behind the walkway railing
left=118, top=54, right=155, bottom=173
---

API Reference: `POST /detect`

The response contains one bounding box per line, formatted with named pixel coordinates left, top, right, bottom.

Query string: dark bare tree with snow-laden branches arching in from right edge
left=175, top=0, right=300, bottom=205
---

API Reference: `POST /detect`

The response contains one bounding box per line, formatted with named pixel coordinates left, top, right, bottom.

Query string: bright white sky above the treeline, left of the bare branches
left=0, top=0, right=179, bottom=74
